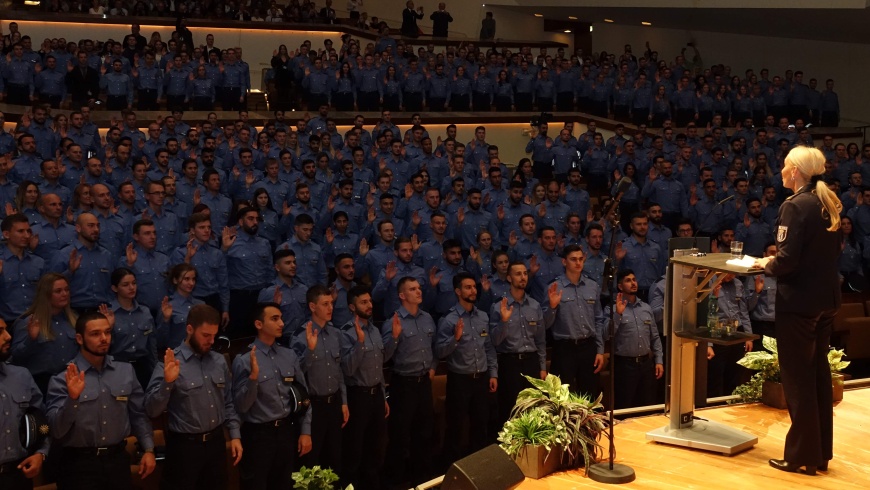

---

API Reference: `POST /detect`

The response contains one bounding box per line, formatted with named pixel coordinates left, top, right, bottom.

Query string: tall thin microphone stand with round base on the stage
left=587, top=192, right=636, bottom=484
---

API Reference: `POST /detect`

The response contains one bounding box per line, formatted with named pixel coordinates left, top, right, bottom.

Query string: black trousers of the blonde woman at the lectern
left=776, top=310, right=837, bottom=466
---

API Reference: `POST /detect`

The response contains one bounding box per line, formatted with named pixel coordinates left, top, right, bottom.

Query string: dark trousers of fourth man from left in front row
left=239, top=416, right=299, bottom=490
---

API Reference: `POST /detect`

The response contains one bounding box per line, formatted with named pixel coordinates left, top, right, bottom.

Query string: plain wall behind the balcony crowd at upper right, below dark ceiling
left=592, top=23, right=870, bottom=126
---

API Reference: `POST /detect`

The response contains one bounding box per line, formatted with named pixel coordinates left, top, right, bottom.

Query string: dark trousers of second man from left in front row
left=52, top=441, right=130, bottom=490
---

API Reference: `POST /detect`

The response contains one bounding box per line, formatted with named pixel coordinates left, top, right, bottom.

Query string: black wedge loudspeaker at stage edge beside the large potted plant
left=441, top=444, right=525, bottom=490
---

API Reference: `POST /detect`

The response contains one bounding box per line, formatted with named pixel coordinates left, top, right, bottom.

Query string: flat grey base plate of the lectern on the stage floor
left=646, top=420, right=758, bottom=455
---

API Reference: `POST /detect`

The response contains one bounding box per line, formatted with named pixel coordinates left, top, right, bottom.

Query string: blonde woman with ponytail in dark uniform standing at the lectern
left=756, top=146, right=843, bottom=475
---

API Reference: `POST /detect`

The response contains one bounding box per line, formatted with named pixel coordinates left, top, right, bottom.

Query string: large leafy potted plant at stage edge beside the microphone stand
left=498, top=374, right=607, bottom=478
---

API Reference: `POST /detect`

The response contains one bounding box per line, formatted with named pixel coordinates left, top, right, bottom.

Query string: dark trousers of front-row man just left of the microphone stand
left=552, top=337, right=601, bottom=399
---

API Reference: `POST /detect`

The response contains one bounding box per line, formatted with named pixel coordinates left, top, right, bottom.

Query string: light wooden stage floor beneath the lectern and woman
left=518, top=389, right=870, bottom=490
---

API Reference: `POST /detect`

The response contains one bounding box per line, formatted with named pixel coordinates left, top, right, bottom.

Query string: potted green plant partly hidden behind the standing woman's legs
left=732, top=336, right=849, bottom=409
